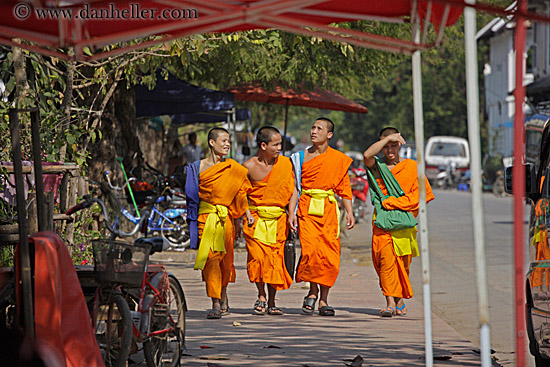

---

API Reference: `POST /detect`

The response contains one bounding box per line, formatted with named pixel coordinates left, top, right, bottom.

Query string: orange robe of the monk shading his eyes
left=372, top=159, right=434, bottom=298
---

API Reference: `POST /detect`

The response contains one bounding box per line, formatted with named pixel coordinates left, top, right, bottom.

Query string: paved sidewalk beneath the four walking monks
left=153, top=243, right=496, bottom=367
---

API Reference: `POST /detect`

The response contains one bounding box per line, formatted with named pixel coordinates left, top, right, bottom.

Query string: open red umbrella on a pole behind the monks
left=227, top=82, right=369, bottom=153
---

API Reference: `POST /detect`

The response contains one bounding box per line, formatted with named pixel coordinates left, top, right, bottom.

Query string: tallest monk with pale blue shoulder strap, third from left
left=288, top=117, right=355, bottom=316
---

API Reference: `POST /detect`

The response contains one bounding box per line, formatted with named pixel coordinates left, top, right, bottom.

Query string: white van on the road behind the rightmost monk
left=425, top=136, right=470, bottom=182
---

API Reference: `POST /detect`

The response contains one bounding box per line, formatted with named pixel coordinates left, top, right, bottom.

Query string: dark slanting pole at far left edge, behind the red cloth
left=9, top=109, right=34, bottom=339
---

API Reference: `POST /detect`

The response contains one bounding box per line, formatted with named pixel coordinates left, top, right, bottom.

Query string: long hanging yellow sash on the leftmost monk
left=194, top=201, right=228, bottom=270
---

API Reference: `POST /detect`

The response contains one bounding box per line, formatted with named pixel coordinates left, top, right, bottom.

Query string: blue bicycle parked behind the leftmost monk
left=105, top=171, right=191, bottom=249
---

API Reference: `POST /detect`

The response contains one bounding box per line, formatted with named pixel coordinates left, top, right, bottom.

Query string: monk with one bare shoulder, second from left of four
left=243, top=126, right=294, bottom=315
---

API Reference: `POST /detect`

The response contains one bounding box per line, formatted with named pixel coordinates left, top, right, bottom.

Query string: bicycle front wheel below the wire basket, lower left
left=92, top=293, right=132, bottom=367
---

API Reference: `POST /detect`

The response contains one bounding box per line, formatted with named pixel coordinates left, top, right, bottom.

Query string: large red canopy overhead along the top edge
left=0, top=0, right=463, bottom=59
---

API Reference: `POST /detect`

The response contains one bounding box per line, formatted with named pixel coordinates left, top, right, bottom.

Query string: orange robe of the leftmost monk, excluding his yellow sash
left=197, top=159, right=250, bottom=298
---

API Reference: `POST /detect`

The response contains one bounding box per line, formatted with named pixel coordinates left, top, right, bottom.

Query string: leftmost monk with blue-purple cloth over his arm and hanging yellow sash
left=185, top=128, right=253, bottom=319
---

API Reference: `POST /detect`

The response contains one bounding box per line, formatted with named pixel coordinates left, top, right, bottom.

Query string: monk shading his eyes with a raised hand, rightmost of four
left=363, top=127, right=434, bottom=317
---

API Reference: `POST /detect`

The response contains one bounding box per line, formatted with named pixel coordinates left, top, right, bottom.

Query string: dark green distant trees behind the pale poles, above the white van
left=324, top=9, right=512, bottom=151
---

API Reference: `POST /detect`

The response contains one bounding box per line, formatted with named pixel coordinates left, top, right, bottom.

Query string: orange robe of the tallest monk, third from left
left=296, top=147, right=352, bottom=287
